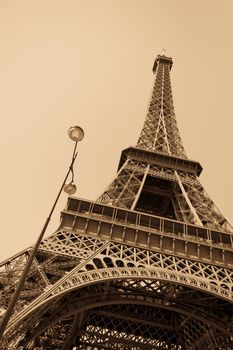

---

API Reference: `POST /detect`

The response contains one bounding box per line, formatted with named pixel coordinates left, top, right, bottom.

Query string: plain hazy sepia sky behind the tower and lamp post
left=0, top=0, right=233, bottom=260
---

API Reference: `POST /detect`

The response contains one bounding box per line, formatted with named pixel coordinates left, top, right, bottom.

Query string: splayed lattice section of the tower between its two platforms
left=97, top=158, right=233, bottom=232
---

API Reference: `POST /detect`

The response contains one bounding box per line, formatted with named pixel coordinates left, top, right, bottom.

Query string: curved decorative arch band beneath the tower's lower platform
left=5, top=267, right=232, bottom=342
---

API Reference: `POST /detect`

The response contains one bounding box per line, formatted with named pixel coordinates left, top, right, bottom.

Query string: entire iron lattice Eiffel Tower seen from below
left=0, top=54, right=233, bottom=350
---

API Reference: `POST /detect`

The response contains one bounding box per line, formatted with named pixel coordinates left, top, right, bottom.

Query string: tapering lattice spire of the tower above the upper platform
left=137, top=56, right=186, bottom=158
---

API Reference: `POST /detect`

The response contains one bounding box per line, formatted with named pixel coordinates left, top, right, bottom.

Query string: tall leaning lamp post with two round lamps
left=0, top=126, right=84, bottom=340
